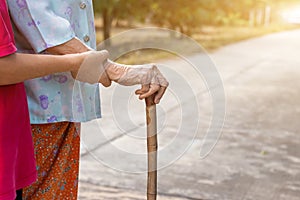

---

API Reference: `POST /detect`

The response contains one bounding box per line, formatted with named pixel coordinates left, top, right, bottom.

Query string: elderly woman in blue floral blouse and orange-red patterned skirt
left=8, top=0, right=168, bottom=200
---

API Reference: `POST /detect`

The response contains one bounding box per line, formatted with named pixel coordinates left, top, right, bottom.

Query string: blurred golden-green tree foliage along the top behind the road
left=94, top=0, right=298, bottom=39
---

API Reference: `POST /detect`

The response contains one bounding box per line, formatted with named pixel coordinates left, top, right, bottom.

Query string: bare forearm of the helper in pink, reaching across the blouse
left=0, top=53, right=84, bottom=85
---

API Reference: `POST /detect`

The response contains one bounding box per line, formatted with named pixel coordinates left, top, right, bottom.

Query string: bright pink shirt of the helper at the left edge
left=0, top=0, right=36, bottom=200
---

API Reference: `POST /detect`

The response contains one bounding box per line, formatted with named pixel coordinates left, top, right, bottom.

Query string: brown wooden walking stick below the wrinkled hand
left=145, top=95, right=157, bottom=200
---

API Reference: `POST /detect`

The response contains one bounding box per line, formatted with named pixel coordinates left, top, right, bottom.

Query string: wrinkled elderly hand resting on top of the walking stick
left=105, top=60, right=169, bottom=104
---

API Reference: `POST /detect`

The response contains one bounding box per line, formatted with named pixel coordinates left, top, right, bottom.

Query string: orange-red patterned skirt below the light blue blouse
left=23, top=122, right=80, bottom=200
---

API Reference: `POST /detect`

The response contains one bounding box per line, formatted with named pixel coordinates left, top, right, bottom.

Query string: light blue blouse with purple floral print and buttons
left=8, top=0, right=101, bottom=124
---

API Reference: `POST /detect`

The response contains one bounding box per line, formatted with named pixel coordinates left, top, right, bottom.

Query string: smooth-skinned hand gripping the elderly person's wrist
left=71, top=50, right=111, bottom=87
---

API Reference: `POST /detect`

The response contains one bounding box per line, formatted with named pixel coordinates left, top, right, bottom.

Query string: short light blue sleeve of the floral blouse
left=8, top=0, right=75, bottom=53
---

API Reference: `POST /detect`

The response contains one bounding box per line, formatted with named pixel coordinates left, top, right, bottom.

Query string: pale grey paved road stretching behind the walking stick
left=79, top=30, right=300, bottom=200
